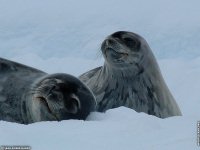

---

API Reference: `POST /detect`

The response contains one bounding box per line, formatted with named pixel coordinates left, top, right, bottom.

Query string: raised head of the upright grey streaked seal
left=101, top=31, right=144, bottom=68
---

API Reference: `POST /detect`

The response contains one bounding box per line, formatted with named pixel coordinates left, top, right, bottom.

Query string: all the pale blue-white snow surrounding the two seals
left=0, top=0, right=200, bottom=150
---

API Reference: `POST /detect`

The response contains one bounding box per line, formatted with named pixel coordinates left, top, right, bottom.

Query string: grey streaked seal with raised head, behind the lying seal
left=79, top=31, right=181, bottom=118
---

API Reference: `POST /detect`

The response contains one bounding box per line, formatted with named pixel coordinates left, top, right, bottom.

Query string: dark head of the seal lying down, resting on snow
left=28, top=74, right=96, bottom=122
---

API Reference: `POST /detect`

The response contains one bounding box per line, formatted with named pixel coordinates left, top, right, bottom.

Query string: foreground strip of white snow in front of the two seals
left=0, top=107, right=196, bottom=150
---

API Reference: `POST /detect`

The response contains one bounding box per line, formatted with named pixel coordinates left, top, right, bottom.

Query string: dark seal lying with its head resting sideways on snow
left=0, top=58, right=96, bottom=124
